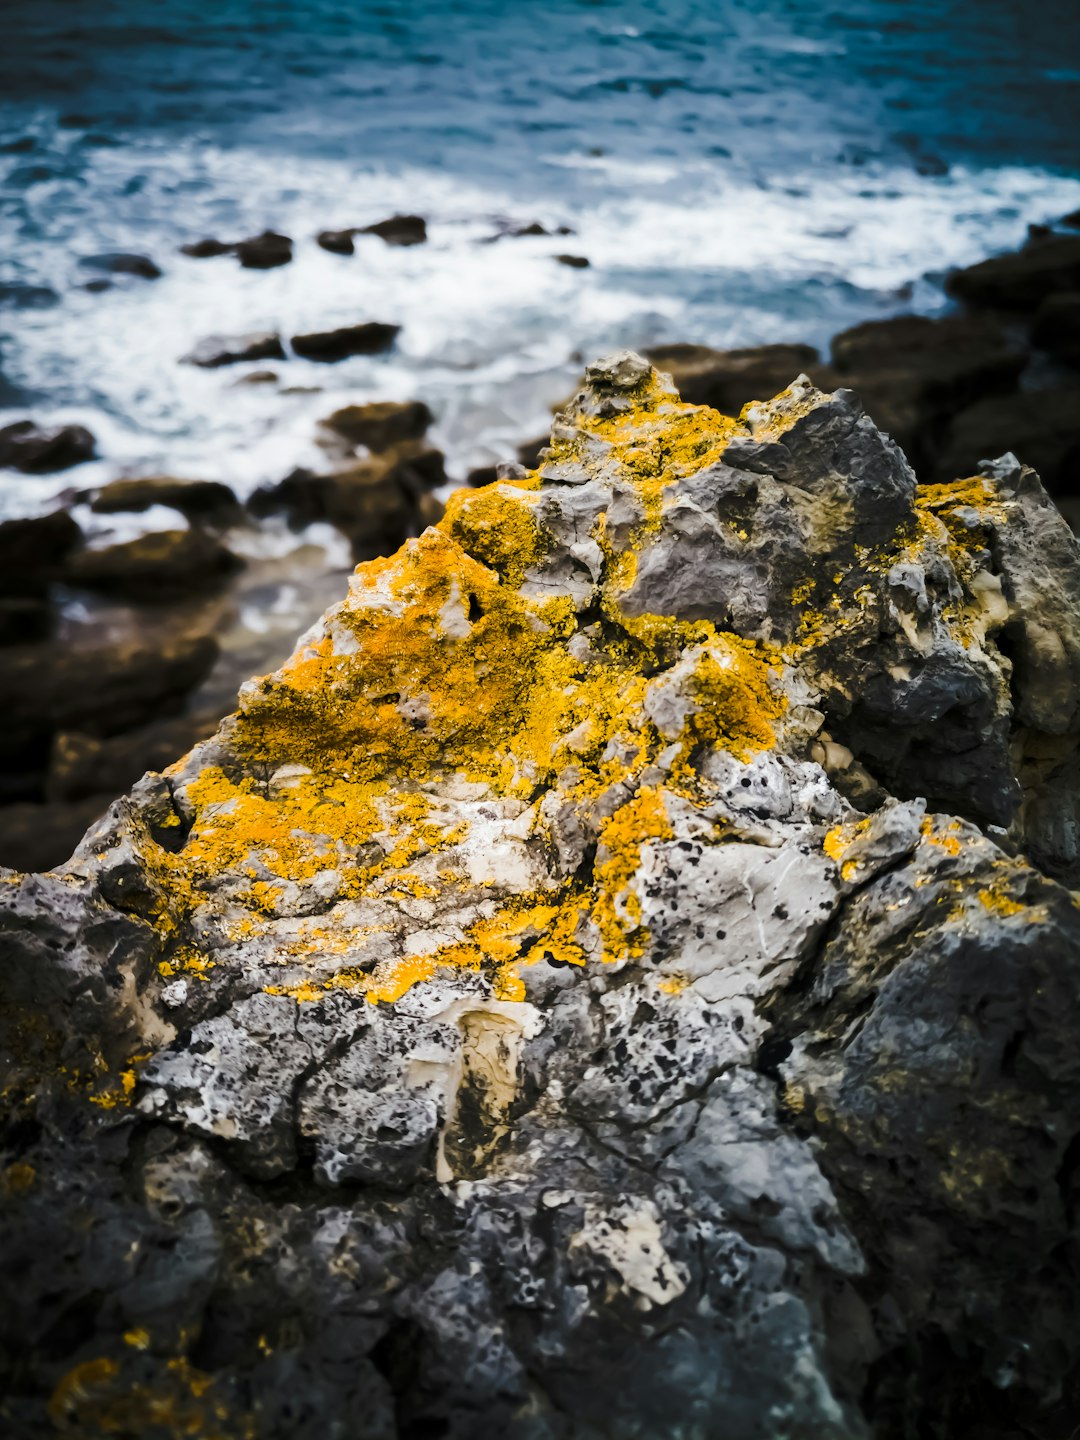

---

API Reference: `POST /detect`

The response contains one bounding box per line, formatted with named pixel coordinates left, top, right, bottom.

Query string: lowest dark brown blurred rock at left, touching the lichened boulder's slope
left=46, top=714, right=217, bottom=806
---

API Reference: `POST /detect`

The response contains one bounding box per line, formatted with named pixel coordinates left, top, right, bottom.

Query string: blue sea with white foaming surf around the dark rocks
left=0, top=0, right=1080, bottom=511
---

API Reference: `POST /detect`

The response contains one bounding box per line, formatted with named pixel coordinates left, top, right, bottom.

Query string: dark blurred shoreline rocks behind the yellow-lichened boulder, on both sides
left=0, top=216, right=1080, bottom=868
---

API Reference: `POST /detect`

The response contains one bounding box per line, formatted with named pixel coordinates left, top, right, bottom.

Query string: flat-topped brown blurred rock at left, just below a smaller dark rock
left=65, top=530, right=243, bottom=605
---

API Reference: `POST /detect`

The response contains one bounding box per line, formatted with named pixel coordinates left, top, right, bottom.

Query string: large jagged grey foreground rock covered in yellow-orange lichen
left=0, top=354, right=1080, bottom=1440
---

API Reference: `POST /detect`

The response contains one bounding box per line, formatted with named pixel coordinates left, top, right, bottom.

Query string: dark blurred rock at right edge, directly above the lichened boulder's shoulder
left=937, top=384, right=1080, bottom=495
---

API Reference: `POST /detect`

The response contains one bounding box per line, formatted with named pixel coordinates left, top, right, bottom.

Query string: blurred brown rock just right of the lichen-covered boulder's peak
left=648, top=344, right=835, bottom=415
